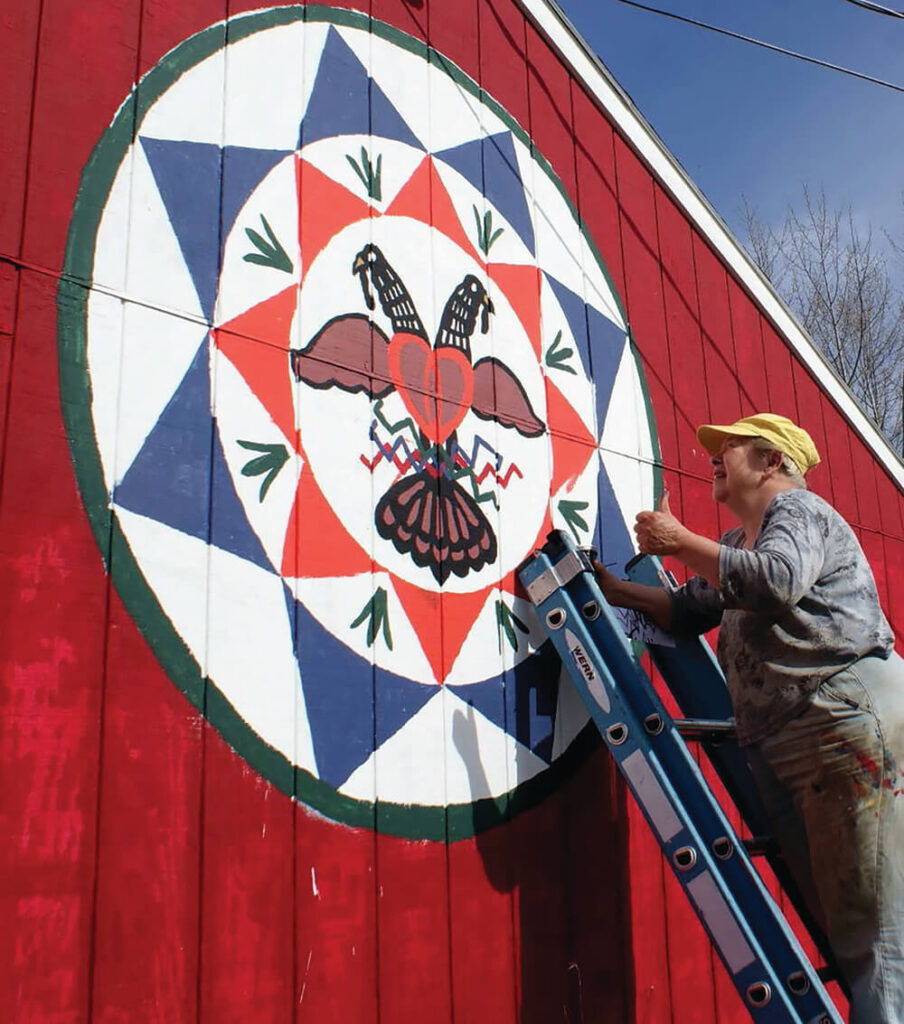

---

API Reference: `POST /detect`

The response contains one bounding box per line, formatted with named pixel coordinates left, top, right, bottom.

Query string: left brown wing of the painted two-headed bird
left=291, top=313, right=395, bottom=398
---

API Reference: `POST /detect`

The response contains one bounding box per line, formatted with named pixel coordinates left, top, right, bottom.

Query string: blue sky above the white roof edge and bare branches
left=559, top=0, right=904, bottom=245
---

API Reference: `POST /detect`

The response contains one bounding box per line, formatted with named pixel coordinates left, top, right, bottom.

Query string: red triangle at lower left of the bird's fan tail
left=281, top=464, right=374, bottom=580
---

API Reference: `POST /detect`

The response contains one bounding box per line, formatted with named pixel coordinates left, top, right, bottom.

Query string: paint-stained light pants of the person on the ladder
left=748, top=653, right=904, bottom=1024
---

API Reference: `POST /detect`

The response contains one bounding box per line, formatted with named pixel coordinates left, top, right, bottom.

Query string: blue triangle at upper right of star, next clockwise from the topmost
left=434, top=131, right=534, bottom=255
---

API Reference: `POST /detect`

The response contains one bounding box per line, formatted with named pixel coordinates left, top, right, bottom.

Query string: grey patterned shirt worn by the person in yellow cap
left=672, top=490, right=895, bottom=745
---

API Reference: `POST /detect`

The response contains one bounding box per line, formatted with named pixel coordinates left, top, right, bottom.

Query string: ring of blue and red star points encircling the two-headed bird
left=115, top=22, right=631, bottom=787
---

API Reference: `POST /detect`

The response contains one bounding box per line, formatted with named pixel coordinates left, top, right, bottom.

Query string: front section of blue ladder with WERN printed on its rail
left=518, top=530, right=843, bottom=1024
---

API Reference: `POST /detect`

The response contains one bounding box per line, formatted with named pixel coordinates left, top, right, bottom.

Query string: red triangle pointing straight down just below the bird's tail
left=392, top=577, right=492, bottom=684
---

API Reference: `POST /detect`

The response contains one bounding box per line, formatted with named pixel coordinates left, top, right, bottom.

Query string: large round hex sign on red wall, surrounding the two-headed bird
left=59, top=7, right=656, bottom=839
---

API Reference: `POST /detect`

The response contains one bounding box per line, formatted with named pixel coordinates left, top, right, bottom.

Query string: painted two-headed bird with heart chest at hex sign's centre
left=291, top=245, right=546, bottom=585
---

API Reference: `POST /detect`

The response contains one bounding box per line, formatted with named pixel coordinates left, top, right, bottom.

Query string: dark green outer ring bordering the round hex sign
left=57, top=5, right=658, bottom=842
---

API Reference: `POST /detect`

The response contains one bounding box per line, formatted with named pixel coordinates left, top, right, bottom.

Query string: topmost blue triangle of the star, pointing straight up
left=298, top=27, right=424, bottom=150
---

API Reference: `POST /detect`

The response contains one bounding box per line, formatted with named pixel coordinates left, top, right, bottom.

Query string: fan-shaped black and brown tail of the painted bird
left=374, top=470, right=497, bottom=586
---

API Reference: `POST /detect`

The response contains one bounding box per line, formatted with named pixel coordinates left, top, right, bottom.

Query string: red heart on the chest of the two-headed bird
left=389, top=333, right=474, bottom=444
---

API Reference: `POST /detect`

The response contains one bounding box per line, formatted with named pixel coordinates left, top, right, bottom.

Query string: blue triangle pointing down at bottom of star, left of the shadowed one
left=286, top=588, right=438, bottom=786
